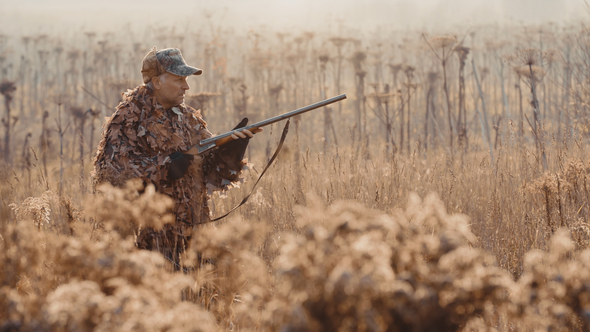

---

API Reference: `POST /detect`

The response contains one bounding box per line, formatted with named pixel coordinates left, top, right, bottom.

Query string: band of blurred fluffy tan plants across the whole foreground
left=5, top=161, right=590, bottom=331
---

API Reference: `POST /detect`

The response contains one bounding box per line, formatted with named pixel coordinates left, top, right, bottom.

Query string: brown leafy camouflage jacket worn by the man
left=92, top=85, right=247, bottom=225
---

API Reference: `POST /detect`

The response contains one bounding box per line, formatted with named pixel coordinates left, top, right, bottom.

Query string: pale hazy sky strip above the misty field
left=0, top=0, right=590, bottom=33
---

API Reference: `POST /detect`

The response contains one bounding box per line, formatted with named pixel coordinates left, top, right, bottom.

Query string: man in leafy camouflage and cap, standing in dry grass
left=92, top=47, right=262, bottom=268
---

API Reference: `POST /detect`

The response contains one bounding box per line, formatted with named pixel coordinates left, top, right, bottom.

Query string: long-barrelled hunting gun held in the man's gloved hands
left=186, top=94, right=346, bottom=155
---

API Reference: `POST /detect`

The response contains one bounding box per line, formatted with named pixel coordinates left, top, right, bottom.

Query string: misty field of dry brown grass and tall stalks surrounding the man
left=0, top=6, right=590, bottom=331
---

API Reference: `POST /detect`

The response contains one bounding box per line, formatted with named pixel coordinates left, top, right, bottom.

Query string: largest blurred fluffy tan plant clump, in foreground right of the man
left=263, top=194, right=512, bottom=331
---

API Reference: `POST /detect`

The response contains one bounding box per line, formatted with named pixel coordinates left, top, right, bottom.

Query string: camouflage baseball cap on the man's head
left=141, top=46, right=203, bottom=83
